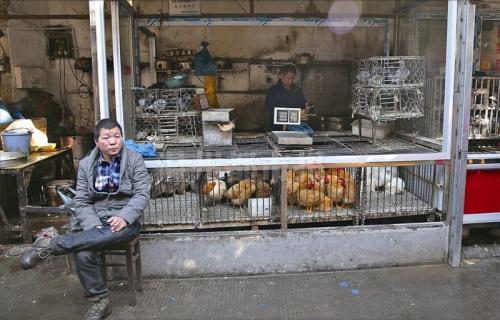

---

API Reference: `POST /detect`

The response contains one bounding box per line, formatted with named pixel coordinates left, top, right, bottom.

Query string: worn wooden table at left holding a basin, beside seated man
left=0, top=148, right=75, bottom=243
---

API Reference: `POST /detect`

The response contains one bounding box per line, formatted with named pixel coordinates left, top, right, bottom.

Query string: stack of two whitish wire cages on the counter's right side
left=352, top=56, right=425, bottom=121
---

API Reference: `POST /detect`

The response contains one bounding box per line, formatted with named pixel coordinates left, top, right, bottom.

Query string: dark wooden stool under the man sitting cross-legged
left=99, top=236, right=142, bottom=306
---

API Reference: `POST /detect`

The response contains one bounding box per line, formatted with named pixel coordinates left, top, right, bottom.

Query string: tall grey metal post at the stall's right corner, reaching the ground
left=448, top=0, right=476, bottom=267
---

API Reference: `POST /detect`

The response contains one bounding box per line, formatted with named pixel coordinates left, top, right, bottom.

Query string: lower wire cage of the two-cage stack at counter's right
left=352, top=87, right=424, bottom=121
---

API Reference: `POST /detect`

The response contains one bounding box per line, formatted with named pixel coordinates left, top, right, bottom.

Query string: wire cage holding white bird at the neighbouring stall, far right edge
left=469, top=77, right=500, bottom=139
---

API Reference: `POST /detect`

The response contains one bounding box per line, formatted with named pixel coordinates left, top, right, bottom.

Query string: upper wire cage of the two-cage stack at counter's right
left=356, top=56, right=426, bottom=87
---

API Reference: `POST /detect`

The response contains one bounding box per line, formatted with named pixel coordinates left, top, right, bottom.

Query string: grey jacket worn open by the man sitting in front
left=73, top=147, right=151, bottom=230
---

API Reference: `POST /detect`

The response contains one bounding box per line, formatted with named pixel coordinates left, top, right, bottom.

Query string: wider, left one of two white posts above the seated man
left=89, top=0, right=109, bottom=119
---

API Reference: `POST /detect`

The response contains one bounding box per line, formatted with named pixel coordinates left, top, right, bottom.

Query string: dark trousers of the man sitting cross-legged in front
left=51, top=218, right=141, bottom=301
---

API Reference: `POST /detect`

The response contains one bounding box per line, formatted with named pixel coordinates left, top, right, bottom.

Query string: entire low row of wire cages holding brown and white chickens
left=144, top=164, right=444, bottom=229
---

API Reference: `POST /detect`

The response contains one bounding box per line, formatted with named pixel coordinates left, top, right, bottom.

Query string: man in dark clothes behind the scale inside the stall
left=266, top=64, right=313, bottom=134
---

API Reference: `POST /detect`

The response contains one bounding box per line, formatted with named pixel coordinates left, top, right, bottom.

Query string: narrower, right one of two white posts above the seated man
left=111, top=1, right=126, bottom=132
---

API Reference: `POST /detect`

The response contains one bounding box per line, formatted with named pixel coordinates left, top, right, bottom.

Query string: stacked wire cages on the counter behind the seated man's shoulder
left=132, top=88, right=201, bottom=148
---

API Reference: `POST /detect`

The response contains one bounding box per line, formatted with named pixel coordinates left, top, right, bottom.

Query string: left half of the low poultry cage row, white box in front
left=144, top=169, right=279, bottom=228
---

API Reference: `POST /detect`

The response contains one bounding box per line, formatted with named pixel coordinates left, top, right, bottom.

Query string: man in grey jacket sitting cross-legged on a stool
left=21, top=119, right=151, bottom=319
